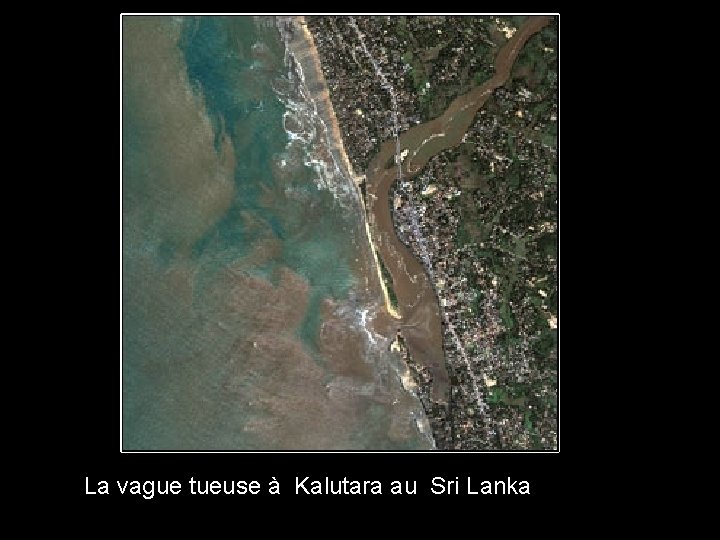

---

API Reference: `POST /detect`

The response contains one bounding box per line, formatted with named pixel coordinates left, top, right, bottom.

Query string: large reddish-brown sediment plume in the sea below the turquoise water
left=205, top=245, right=422, bottom=449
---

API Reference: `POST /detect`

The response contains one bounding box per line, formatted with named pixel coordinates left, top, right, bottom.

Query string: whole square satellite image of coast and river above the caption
left=120, top=15, right=559, bottom=451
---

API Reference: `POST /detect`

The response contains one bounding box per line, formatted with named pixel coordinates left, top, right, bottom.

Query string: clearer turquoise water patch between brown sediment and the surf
left=180, top=17, right=353, bottom=349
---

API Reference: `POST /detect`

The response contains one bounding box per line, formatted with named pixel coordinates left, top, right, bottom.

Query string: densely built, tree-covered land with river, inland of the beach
left=309, top=16, right=558, bottom=450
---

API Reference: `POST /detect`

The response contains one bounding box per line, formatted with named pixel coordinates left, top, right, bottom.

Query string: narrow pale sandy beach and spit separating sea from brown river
left=278, top=15, right=402, bottom=320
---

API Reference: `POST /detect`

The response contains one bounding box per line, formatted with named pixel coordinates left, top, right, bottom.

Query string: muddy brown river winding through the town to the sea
left=365, top=16, right=551, bottom=403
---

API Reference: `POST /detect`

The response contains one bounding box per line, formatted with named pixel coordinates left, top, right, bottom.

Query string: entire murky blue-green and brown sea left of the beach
left=122, top=17, right=432, bottom=450
